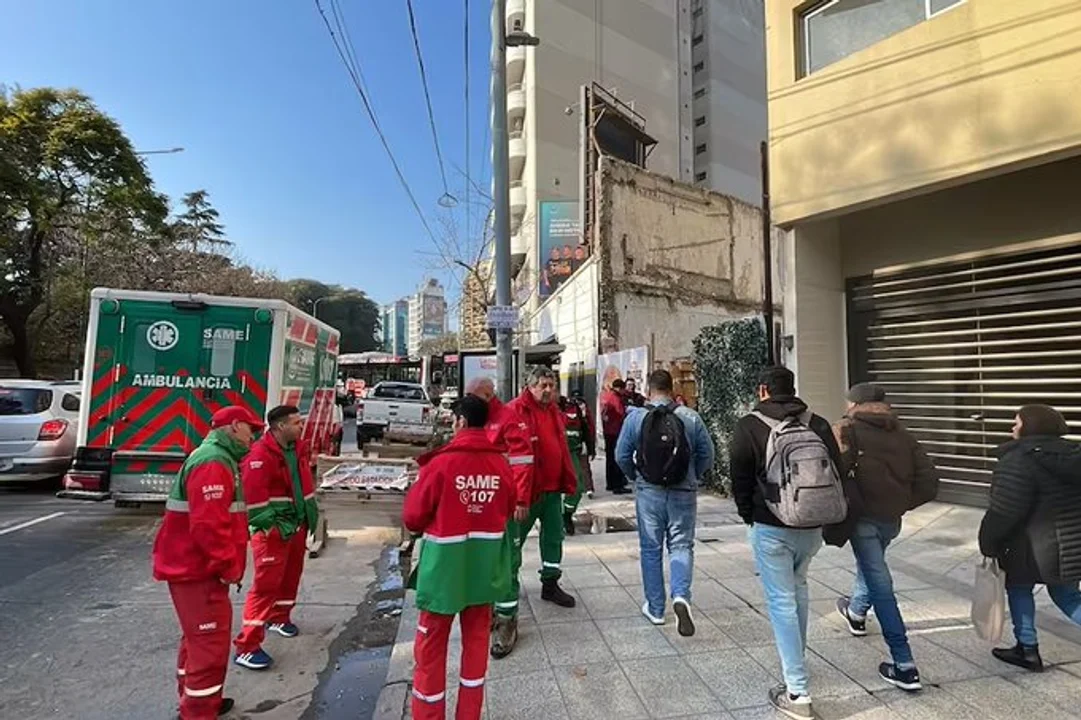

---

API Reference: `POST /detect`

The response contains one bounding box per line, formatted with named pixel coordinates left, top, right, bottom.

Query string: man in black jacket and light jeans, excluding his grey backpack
left=730, top=368, right=841, bottom=718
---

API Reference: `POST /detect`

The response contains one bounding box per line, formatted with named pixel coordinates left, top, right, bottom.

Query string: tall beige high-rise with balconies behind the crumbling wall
left=507, top=0, right=766, bottom=315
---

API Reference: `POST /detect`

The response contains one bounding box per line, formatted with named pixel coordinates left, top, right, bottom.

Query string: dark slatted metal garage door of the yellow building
left=846, top=242, right=1081, bottom=504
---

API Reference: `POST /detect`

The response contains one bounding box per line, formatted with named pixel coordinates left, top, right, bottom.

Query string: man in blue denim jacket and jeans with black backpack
left=616, top=370, right=713, bottom=637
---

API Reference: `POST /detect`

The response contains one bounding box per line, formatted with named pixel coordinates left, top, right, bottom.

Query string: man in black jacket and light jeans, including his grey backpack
left=730, top=368, right=849, bottom=719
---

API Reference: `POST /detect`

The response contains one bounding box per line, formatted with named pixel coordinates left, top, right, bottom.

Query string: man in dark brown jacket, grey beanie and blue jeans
left=833, top=383, right=938, bottom=692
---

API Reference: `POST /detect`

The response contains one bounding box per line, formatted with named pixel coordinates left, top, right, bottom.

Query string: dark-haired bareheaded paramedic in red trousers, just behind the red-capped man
left=235, top=405, right=319, bottom=670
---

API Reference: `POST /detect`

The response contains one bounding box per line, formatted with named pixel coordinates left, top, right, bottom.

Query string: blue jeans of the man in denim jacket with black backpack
left=635, top=482, right=698, bottom=617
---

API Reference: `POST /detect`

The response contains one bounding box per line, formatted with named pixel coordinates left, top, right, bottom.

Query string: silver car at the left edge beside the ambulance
left=0, top=379, right=82, bottom=483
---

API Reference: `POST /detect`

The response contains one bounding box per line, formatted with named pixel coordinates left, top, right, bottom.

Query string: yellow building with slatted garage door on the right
left=765, top=0, right=1081, bottom=502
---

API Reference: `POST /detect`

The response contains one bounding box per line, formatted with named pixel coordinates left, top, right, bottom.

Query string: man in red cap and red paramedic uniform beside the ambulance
left=152, top=406, right=263, bottom=720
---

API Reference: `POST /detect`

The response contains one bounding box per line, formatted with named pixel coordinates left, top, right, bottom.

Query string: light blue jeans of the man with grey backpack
left=747, top=523, right=822, bottom=695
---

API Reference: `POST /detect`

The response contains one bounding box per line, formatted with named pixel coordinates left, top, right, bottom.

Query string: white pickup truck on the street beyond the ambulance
left=357, top=382, right=436, bottom=448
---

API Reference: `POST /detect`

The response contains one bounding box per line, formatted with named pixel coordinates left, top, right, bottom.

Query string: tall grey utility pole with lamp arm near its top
left=491, top=0, right=541, bottom=402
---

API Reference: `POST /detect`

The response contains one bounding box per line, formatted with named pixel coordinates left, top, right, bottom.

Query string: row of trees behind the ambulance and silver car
left=0, top=88, right=379, bottom=377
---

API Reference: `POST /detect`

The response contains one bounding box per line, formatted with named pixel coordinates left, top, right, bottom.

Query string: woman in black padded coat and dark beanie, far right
left=979, top=405, right=1081, bottom=672
